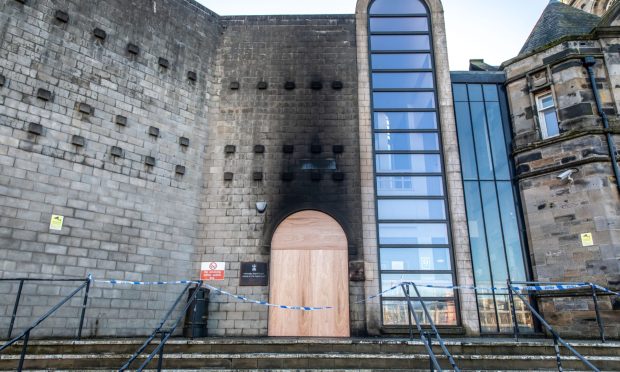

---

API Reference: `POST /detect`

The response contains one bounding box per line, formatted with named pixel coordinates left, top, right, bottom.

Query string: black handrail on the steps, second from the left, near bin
left=118, top=281, right=202, bottom=372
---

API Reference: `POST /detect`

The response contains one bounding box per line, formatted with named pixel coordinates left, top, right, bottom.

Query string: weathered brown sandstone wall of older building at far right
left=506, top=40, right=620, bottom=337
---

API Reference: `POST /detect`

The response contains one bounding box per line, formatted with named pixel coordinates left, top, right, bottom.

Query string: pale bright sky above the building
left=196, top=0, right=549, bottom=70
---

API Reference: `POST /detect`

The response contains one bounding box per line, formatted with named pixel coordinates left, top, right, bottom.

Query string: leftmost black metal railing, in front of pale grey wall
left=0, top=276, right=92, bottom=372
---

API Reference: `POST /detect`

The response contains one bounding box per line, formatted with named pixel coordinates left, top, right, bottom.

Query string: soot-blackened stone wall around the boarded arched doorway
left=200, top=16, right=365, bottom=335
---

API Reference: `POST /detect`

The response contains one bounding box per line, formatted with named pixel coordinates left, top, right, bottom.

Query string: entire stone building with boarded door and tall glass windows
left=0, top=0, right=620, bottom=337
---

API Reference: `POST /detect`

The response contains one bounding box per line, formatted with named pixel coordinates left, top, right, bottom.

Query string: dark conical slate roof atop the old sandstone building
left=519, top=1, right=601, bottom=54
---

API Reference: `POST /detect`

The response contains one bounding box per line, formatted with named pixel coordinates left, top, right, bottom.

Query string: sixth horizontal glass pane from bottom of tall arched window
left=377, top=176, right=443, bottom=196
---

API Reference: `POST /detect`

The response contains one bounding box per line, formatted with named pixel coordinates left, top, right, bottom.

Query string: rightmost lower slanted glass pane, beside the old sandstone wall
left=497, top=182, right=526, bottom=281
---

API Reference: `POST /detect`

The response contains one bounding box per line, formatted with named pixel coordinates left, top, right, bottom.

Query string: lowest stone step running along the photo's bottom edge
left=0, top=353, right=620, bottom=371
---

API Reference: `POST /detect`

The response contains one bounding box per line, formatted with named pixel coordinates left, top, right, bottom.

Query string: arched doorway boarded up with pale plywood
left=269, top=211, right=350, bottom=337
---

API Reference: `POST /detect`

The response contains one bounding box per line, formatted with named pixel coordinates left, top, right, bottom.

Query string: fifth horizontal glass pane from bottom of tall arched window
left=377, top=200, right=446, bottom=220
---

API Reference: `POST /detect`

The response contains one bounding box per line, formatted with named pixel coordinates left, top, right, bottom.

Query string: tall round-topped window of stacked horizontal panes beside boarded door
left=368, top=0, right=458, bottom=326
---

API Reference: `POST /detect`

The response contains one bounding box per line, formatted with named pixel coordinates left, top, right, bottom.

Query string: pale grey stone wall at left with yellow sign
left=0, top=0, right=220, bottom=337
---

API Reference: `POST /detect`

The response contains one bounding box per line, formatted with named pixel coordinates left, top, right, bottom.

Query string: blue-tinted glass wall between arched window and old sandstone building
left=453, top=84, right=532, bottom=333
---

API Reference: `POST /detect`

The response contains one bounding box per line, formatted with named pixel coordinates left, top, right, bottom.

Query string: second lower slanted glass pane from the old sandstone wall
left=480, top=181, right=508, bottom=286
